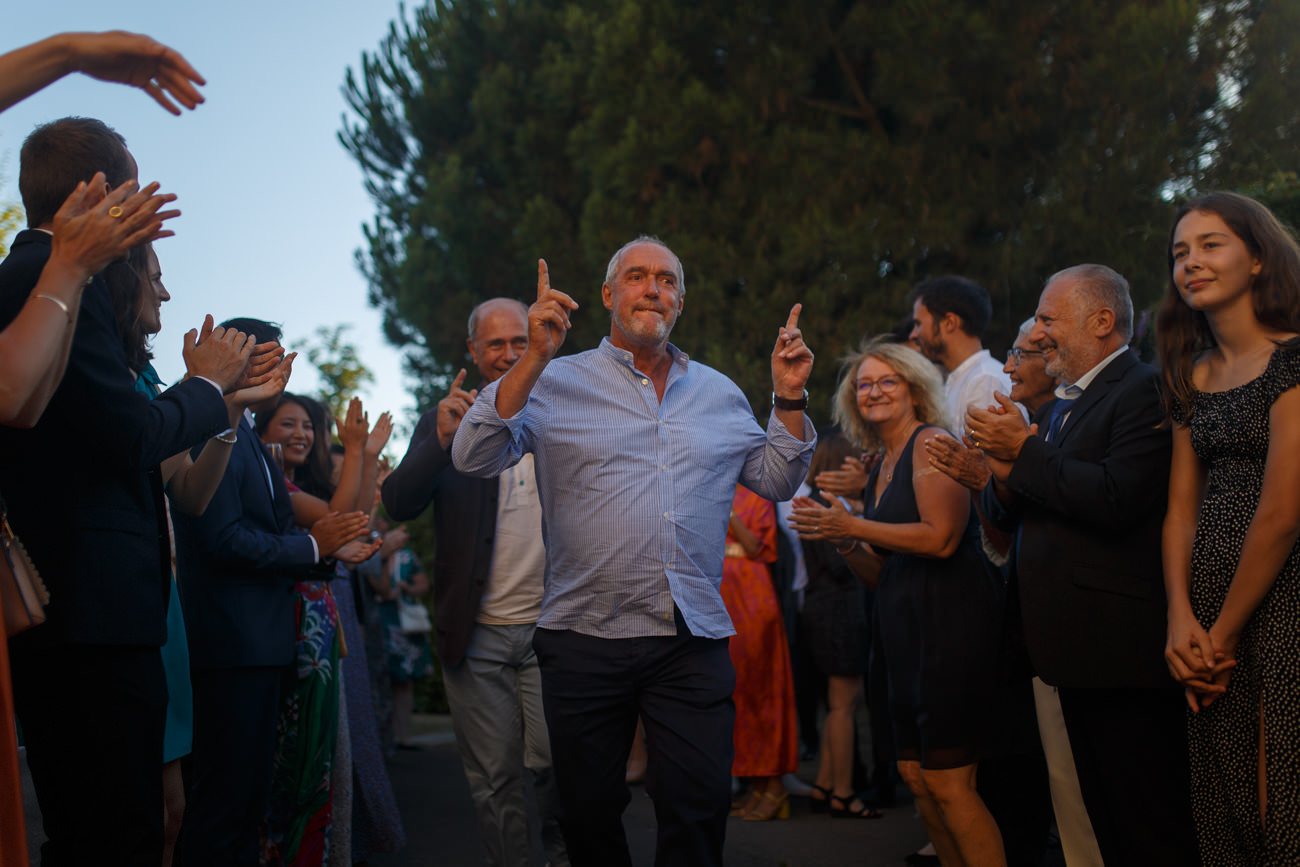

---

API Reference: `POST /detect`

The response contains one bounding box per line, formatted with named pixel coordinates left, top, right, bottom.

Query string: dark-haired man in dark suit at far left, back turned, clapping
left=0, top=118, right=252, bottom=866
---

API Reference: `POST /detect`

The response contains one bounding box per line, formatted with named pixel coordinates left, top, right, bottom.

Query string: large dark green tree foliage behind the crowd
left=342, top=0, right=1300, bottom=421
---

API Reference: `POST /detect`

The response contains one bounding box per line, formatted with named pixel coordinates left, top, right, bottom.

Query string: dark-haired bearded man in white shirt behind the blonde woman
left=909, top=274, right=1011, bottom=430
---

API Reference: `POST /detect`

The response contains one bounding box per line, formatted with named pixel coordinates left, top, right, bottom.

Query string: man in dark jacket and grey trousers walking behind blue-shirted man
left=382, top=298, right=568, bottom=867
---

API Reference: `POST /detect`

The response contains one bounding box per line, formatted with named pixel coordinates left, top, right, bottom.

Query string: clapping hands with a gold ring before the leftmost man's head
left=49, top=172, right=181, bottom=278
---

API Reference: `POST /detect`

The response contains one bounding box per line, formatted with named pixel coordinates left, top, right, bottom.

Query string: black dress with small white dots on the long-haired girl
left=1174, top=350, right=1300, bottom=867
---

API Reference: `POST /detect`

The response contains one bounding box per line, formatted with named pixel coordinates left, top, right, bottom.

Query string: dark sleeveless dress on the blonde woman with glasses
left=866, top=428, right=1002, bottom=770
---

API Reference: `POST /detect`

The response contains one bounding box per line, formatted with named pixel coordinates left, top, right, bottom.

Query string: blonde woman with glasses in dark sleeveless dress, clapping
left=792, top=339, right=1006, bottom=867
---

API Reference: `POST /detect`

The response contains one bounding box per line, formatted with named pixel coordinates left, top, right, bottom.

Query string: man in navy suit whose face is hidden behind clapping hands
left=172, top=320, right=367, bottom=867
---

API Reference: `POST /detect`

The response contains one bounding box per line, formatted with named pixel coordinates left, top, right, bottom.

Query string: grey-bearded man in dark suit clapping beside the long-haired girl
left=966, top=265, right=1197, bottom=866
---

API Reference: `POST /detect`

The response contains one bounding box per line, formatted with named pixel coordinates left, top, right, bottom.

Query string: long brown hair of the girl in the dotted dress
left=1156, top=192, right=1300, bottom=416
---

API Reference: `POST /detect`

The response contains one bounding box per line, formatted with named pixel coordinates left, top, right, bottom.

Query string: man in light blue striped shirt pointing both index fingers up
left=452, top=238, right=815, bottom=867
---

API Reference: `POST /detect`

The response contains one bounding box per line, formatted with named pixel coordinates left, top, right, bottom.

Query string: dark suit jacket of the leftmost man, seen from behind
left=0, top=230, right=228, bottom=649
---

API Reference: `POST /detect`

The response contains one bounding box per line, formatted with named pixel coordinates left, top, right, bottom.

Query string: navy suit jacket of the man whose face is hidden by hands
left=172, top=420, right=318, bottom=668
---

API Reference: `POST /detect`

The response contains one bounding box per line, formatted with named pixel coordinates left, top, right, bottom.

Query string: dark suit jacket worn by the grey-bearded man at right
left=980, top=350, right=1174, bottom=688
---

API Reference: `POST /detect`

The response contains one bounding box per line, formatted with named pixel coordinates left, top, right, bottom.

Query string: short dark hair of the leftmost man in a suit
left=18, top=117, right=135, bottom=227
